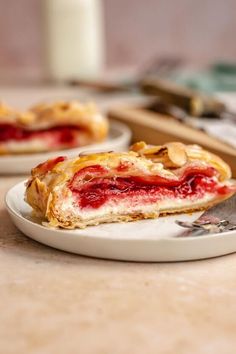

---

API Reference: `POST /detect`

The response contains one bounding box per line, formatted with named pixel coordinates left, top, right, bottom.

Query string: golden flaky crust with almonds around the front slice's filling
left=26, top=142, right=232, bottom=229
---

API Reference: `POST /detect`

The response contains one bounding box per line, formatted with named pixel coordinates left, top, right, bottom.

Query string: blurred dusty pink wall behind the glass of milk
left=0, top=0, right=236, bottom=81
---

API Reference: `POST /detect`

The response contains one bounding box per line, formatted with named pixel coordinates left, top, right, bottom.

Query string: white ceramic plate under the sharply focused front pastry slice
left=6, top=182, right=236, bottom=262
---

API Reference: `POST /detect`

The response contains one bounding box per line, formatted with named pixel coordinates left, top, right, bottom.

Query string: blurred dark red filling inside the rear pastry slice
left=0, top=124, right=84, bottom=145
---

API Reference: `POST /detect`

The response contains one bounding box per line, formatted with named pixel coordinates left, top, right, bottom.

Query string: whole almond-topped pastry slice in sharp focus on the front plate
left=26, top=142, right=236, bottom=229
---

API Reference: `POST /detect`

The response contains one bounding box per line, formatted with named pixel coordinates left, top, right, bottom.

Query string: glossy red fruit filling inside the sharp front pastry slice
left=69, top=165, right=229, bottom=209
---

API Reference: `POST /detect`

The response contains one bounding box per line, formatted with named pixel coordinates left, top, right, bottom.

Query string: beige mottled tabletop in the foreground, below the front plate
left=0, top=88, right=236, bottom=354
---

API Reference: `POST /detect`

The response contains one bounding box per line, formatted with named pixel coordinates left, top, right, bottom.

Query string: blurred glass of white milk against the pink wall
left=44, top=0, right=104, bottom=81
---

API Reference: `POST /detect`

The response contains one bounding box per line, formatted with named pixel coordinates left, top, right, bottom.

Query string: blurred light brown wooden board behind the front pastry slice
left=108, top=107, right=236, bottom=178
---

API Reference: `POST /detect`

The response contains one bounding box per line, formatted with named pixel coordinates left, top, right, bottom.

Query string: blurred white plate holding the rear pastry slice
left=0, top=121, right=131, bottom=174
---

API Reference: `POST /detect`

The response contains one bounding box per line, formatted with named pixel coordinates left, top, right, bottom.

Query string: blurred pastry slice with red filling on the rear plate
left=0, top=101, right=108, bottom=155
